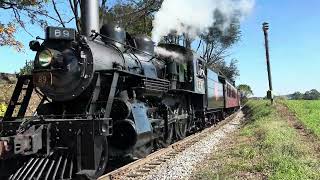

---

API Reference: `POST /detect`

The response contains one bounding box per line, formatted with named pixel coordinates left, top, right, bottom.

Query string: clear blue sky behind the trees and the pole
left=0, top=0, right=320, bottom=96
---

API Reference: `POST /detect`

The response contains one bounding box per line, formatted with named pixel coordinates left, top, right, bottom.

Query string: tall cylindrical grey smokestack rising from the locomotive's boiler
left=81, top=0, right=99, bottom=36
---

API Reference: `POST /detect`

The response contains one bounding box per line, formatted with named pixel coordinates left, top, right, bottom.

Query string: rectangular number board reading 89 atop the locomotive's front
left=46, top=26, right=76, bottom=41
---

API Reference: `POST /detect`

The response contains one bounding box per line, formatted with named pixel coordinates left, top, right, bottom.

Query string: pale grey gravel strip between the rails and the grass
left=139, top=111, right=243, bottom=180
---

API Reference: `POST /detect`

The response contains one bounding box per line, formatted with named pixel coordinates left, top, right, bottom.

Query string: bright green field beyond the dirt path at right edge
left=283, top=100, right=320, bottom=138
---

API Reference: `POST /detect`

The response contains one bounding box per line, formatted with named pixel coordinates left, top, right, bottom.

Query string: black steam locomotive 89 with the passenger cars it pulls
left=0, top=0, right=240, bottom=179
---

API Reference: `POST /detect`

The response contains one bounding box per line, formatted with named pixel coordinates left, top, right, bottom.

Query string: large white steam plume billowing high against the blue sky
left=152, top=0, right=255, bottom=43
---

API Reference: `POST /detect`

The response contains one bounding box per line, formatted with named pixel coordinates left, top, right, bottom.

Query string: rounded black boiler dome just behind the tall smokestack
left=100, top=24, right=126, bottom=51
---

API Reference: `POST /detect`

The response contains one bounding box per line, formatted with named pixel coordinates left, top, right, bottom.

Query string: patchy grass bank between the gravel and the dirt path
left=193, top=101, right=320, bottom=180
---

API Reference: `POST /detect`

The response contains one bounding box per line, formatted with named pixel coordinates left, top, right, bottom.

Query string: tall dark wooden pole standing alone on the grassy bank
left=262, top=22, right=273, bottom=104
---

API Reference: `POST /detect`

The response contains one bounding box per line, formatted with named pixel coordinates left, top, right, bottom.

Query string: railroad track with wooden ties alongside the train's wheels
left=98, top=111, right=240, bottom=180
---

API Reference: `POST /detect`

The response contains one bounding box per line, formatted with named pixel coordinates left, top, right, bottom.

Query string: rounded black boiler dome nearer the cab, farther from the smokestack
left=134, top=35, right=154, bottom=56
